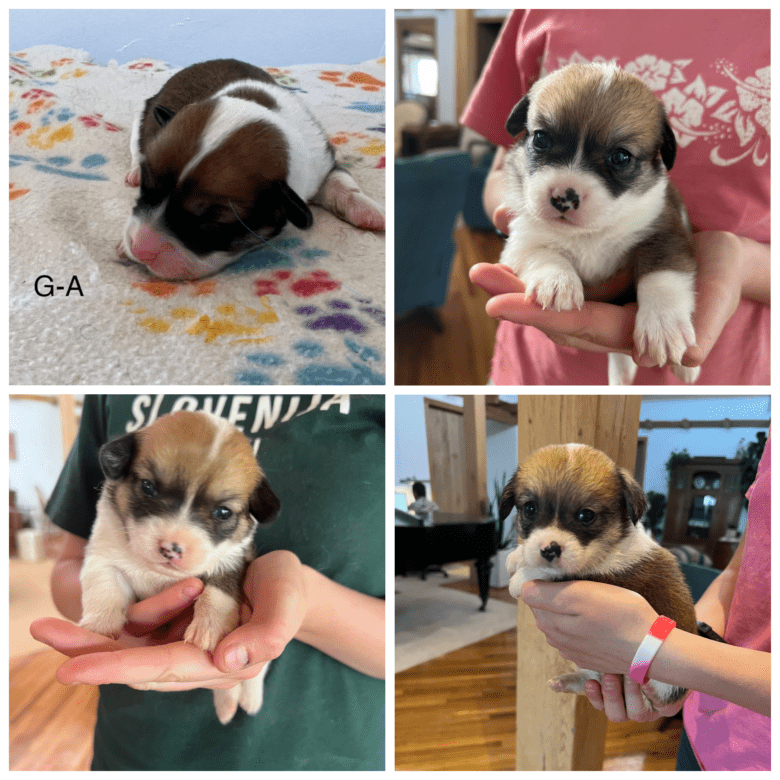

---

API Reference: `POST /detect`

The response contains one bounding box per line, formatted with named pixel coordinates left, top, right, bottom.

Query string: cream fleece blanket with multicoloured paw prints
left=9, top=46, right=385, bottom=385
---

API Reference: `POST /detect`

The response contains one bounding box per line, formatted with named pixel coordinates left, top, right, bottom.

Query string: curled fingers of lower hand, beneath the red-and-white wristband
left=585, top=674, right=688, bottom=723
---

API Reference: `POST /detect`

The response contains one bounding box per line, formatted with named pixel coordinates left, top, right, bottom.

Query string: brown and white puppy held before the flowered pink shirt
left=501, top=64, right=699, bottom=385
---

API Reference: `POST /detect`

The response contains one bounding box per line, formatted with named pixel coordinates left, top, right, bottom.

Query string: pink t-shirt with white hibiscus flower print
left=461, top=9, right=770, bottom=385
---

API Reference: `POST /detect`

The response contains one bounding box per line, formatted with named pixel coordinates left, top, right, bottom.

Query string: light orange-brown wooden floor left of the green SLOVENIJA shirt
left=8, top=650, right=98, bottom=771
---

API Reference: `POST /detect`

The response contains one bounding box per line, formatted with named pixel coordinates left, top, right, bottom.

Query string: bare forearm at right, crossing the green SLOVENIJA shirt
left=295, top=566, right=385, bottom=679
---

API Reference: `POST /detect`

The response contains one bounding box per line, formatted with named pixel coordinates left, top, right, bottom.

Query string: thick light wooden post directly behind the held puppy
left=515, top=395, right=642, bottom=771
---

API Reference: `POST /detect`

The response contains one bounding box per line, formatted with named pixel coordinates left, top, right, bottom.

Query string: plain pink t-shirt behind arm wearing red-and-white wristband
left=683, top=436, right=772, bottom=771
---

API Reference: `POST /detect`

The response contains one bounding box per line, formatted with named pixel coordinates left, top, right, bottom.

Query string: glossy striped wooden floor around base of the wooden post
left=395, top=582, right=682, bottom=771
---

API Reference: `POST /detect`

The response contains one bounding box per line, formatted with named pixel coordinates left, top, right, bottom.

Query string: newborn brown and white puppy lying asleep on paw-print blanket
left=117, top=60, right=385, bottom=279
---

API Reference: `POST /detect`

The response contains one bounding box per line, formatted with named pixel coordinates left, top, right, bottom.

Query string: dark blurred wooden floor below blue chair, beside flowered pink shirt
left=395, top=226, right=504, bottom=385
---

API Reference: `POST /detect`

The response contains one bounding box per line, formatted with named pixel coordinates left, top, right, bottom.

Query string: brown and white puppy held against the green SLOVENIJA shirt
left=79, top=411, right=279, bottom=723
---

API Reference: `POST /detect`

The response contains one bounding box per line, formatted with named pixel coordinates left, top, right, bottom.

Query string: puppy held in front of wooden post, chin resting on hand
left=499, top=444, right=697, bottom=703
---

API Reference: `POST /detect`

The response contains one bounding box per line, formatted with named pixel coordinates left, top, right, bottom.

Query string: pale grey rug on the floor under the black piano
left=395, top=574, right=517, bottom=672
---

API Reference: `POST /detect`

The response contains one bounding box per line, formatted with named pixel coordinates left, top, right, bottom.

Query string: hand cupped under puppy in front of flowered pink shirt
left=478, top=205, right=744, bottom=367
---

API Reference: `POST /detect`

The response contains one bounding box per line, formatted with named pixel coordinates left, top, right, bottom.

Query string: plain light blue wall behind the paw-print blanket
left=9, top=9, right=385, bottom=67
